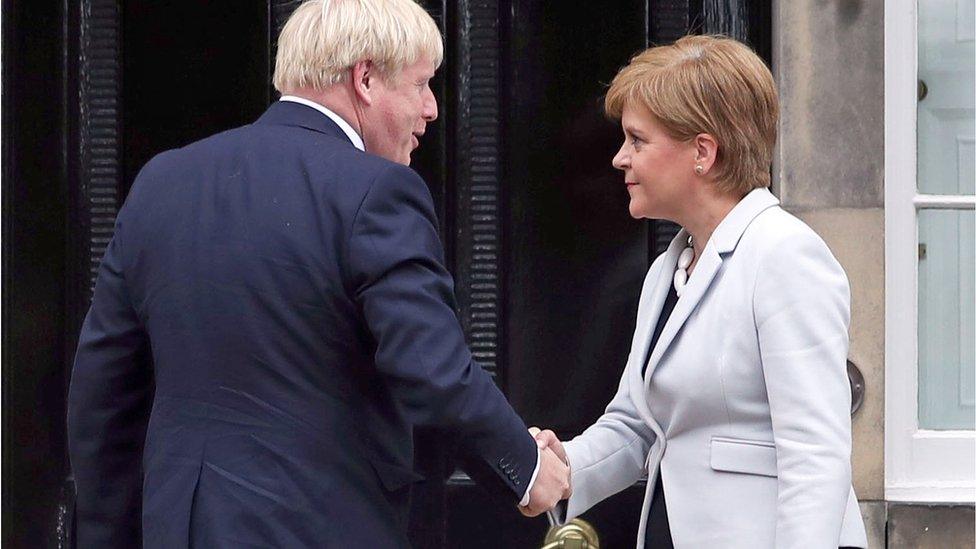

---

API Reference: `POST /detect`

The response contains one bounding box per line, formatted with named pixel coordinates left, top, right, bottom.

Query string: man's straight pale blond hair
left=274, top=0, right=444, bottom=94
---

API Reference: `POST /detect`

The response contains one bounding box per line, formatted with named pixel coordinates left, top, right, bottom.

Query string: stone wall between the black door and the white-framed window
left=772, top=0, right=973, bottom=547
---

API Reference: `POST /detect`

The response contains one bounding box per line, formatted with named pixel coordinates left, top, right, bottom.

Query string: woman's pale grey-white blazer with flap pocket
left=565, top=189, right=867, bottom=548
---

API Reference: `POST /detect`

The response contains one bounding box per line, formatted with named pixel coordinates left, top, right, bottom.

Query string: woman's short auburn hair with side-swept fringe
left=604, top=36, right=779, bottom=194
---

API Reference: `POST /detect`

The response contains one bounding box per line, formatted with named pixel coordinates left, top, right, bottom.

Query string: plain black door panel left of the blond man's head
left=122, top=0, right=269, bottom=196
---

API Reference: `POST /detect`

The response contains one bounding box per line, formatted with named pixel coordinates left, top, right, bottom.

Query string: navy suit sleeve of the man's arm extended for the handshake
left=348, top=166, right=538, bottom=502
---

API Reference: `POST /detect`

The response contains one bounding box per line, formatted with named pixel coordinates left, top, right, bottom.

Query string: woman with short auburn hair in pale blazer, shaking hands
left=536, top=36, right=867, bottom=548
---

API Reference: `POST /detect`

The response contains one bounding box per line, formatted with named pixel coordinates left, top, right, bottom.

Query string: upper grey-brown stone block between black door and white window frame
left=773, top=0, right=884, bottom=209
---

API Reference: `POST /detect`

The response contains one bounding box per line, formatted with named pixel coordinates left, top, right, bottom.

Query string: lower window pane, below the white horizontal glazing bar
left=918, top=210, right=976, bottom=429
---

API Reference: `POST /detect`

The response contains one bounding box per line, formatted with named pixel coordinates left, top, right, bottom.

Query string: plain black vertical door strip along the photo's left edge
left=0, top=0, right=69, bottom=548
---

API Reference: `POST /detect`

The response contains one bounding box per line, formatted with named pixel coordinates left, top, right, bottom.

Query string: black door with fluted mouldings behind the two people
left=3, top=0, right=769, bottom=548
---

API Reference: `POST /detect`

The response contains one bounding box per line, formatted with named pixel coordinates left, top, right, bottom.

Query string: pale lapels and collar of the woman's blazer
left=641, top=188, right=779, bottom=391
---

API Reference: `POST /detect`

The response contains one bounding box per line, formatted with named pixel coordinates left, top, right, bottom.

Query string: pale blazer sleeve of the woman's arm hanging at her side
left=753, top=227, right=851, bottom=547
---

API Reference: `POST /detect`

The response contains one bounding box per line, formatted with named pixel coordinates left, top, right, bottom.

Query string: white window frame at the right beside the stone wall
left=884, top=0, right=976, bottom=503
